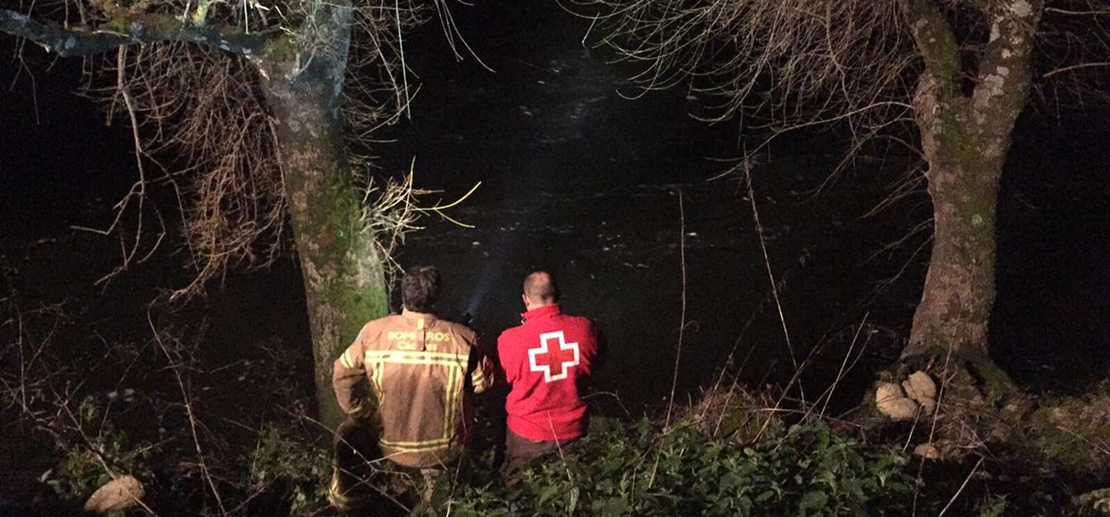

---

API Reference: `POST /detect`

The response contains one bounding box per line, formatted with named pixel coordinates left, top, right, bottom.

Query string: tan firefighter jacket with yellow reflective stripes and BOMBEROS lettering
left=332, top=310, right=493, bottom=468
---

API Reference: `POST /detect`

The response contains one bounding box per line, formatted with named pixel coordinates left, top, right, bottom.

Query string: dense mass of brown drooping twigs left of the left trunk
left=69, top=43, right=286, bottom=296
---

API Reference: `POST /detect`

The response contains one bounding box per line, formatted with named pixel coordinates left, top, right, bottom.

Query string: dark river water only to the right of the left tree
left=382, top=2, right=1110, bottom=407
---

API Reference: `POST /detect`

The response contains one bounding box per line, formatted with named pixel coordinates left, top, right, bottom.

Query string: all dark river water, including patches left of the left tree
left=0, top=1, right=1110, bottom=448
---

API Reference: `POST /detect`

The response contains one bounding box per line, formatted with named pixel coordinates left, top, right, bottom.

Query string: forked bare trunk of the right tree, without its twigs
left=902, top=0, right=1042, bottom=365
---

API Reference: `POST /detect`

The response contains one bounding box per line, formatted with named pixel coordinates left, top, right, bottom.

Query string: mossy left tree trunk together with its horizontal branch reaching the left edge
left=0, top=0, right=389, bottom=429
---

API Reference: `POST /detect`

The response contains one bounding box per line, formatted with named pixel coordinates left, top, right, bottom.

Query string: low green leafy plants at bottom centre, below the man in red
left=448, top=420, right=914, bottom=517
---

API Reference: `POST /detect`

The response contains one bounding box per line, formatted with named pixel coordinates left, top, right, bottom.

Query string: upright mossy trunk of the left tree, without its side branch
left=259, top=2, right=389, bottom=429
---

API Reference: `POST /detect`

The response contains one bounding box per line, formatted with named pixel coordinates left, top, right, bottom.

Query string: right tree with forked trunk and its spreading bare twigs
left=582, top=0, right=1110, bottom=367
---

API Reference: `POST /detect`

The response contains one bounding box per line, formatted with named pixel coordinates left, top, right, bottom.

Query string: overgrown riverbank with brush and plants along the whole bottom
left=8, top=323, right=1110, bottom=517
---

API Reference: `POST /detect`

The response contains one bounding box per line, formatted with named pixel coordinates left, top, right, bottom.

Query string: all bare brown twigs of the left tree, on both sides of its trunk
left=32, top=0, right=426, bottom=297
